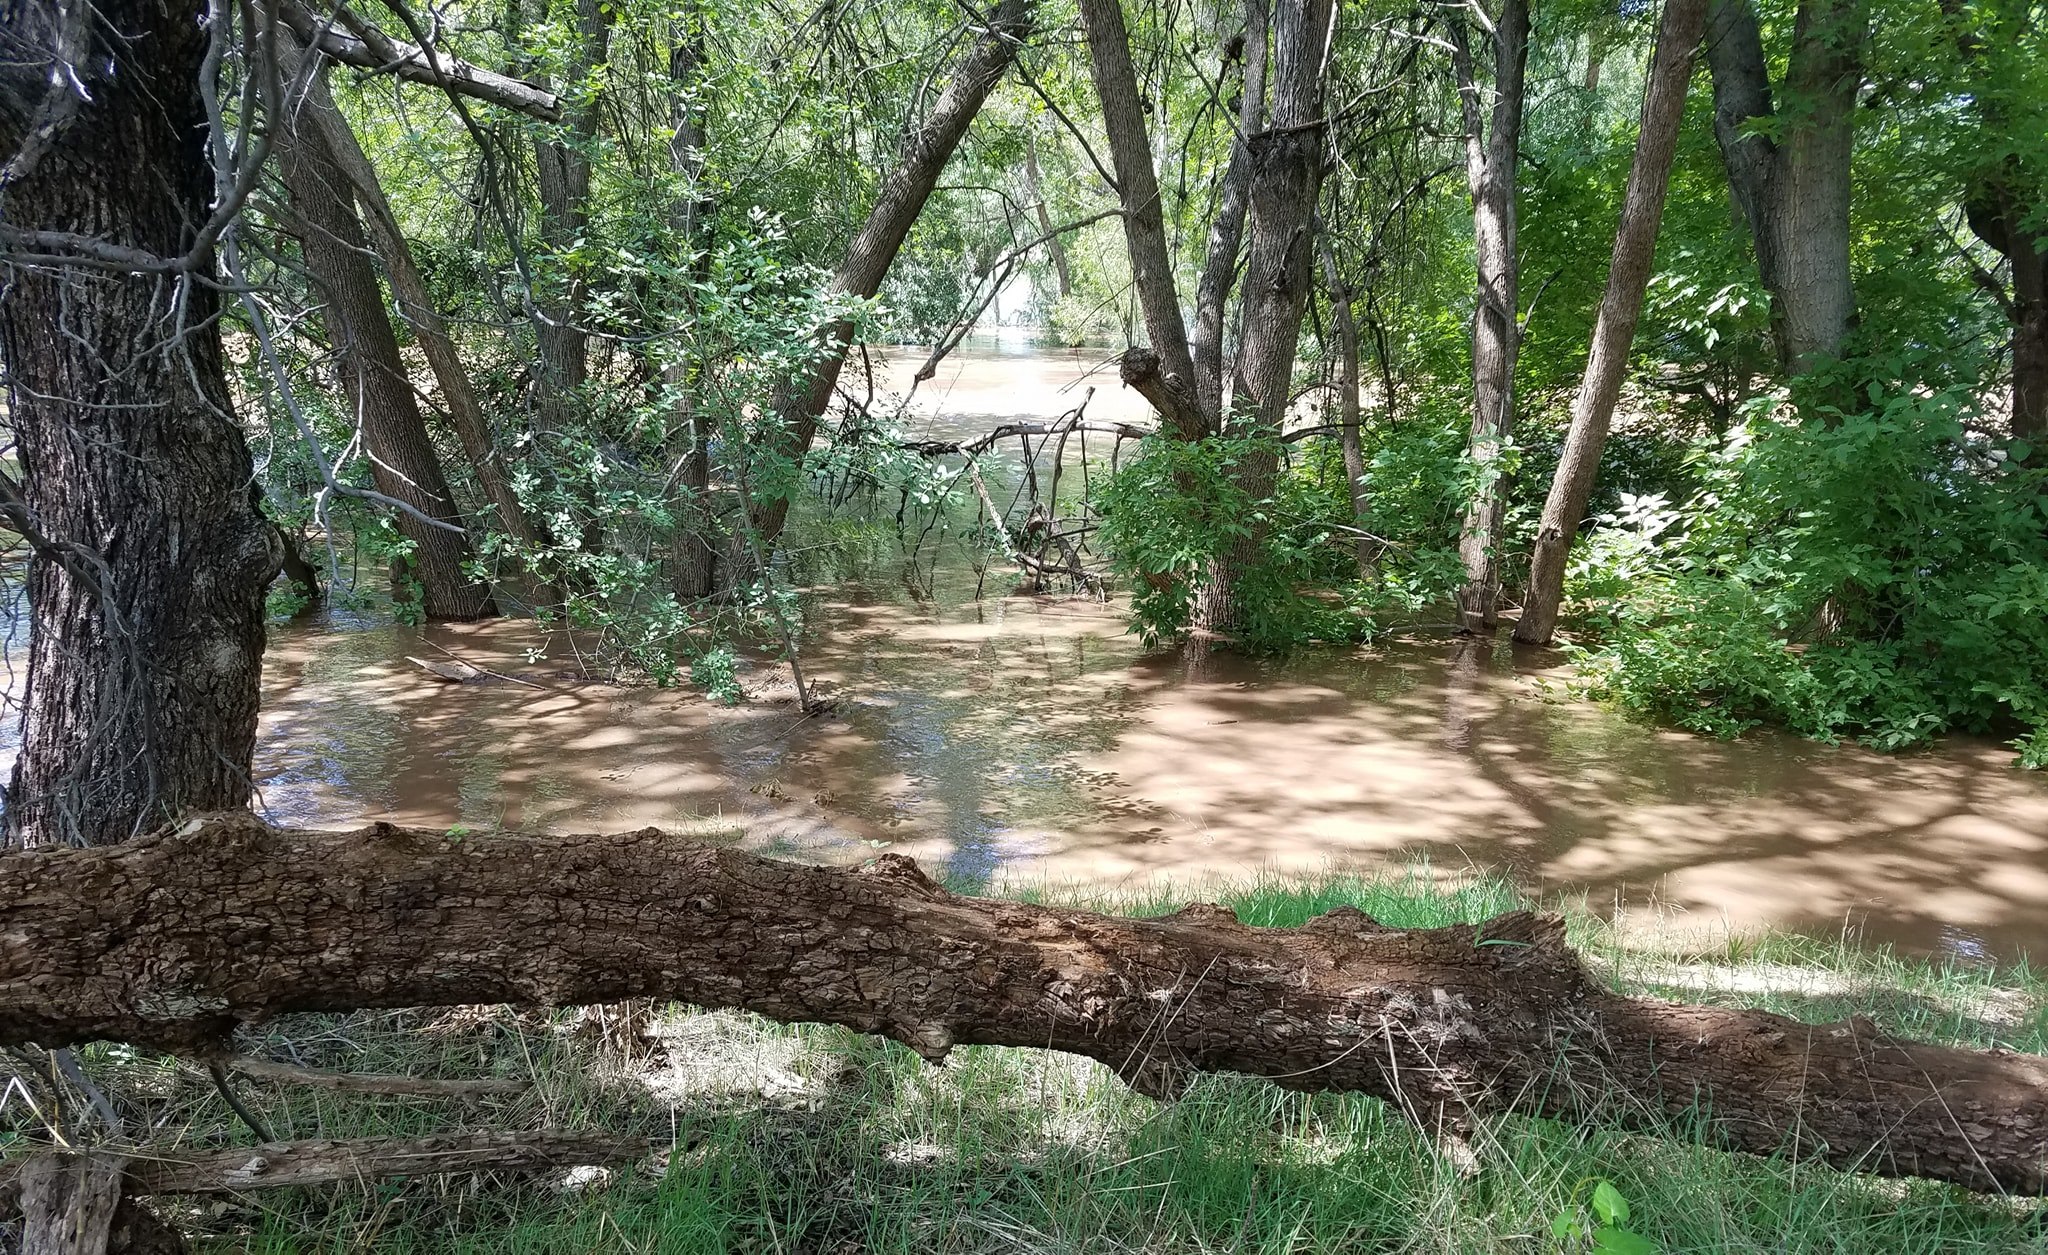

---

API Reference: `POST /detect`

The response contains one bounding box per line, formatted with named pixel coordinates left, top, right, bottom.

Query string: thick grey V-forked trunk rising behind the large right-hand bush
left=1706, top=0, right=1870, bottom=375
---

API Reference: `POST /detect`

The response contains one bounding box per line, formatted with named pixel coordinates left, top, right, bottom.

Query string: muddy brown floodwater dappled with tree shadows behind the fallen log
left=258, top=339, right=2048, bottom=958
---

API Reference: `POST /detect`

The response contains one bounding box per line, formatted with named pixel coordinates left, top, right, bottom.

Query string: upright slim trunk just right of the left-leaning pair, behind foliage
left=532, top=0, right=610, bottom=432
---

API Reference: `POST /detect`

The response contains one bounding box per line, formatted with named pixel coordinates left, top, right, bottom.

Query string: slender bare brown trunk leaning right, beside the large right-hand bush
left=1516, top=0, right=1708, bottom=645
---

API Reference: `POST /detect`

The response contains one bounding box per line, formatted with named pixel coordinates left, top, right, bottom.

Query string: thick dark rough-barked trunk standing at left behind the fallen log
left=0, top=0, right=279, bottom=846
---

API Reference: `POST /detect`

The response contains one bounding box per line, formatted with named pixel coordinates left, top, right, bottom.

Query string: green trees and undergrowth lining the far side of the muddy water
left=123, top=0, right=2015, bottom=766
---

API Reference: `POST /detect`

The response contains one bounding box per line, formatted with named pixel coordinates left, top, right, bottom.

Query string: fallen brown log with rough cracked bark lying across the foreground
left=0, top=813, right=2048, bottom=1194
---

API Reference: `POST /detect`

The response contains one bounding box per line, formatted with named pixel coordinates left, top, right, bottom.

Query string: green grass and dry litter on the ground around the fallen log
left=28, top=868, right=2048, bottom=1255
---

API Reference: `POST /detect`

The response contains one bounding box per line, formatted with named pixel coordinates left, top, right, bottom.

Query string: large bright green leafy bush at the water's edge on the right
left=1571, top=364, right=2048, bottom=766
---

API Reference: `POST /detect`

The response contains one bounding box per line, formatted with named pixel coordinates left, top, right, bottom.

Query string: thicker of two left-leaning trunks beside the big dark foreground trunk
left=276, top=57, right=496, bottom=618
